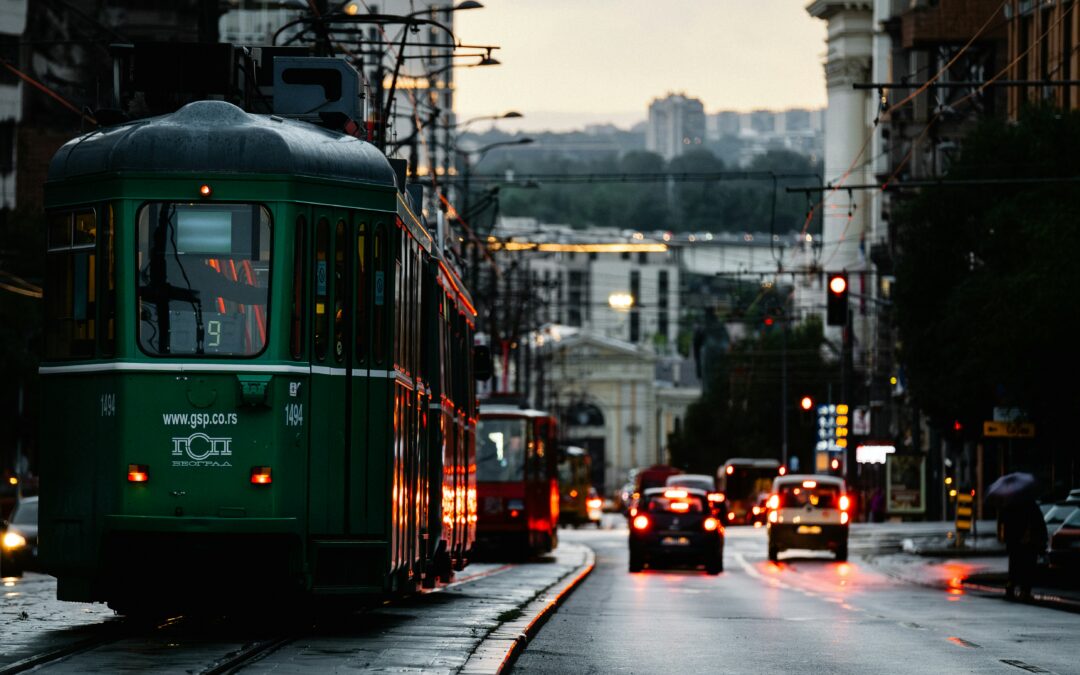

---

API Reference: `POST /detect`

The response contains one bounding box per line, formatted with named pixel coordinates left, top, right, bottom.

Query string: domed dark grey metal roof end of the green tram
left=49, top=100, right=396, bottom=187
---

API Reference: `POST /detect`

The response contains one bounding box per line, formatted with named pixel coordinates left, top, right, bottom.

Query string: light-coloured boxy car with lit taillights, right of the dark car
left=766, top=474, right=851, bottom=563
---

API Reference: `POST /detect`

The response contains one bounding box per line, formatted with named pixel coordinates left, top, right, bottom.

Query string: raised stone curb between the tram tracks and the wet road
left=458, top=546, right=596, bottom=675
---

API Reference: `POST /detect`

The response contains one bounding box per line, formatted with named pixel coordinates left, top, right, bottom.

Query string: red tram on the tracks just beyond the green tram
left=476, top=403, right=559, bottom=557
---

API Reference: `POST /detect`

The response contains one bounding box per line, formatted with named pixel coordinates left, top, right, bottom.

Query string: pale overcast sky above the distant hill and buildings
left=455, top=0, right=826, bottom=131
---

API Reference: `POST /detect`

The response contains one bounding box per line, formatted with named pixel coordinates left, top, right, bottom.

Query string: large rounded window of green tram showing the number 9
left=138, top=202, right=270, bottom=356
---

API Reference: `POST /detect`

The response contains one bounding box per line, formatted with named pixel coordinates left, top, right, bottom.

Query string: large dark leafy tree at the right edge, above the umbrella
left=894, top=109, right=1080, bottom=437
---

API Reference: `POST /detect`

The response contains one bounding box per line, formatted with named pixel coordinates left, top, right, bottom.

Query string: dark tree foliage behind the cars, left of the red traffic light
left=671, top=319, right=839, bottom=473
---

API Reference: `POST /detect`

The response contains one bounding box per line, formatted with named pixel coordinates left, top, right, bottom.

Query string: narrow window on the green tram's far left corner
left=44, top=210, right=97, bottom=359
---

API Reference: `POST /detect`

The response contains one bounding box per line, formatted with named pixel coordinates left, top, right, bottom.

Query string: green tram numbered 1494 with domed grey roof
left=40, top=102, right=477, bottom=610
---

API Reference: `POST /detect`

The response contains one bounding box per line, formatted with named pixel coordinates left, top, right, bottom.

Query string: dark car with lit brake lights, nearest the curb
left=630, top=487, right=724, bottom=575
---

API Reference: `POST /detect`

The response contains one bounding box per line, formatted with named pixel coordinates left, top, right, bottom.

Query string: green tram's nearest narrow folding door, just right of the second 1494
left=308, top=207, right=352, bottom=535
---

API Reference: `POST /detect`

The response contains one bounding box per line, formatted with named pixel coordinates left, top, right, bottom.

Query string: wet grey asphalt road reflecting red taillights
left=513, top=523, right=1080, bottom=675
